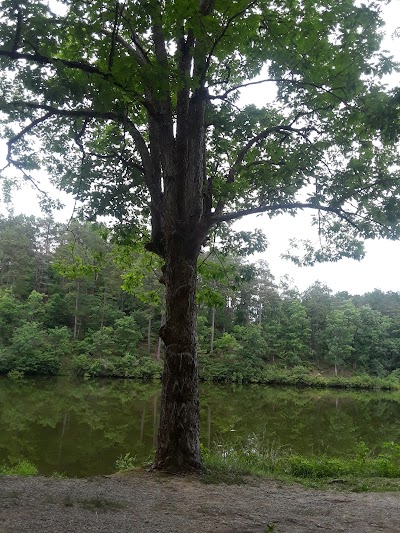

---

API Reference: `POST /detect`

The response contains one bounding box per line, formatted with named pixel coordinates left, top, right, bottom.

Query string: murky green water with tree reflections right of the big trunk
left=203, top=386, right=400, bottom=455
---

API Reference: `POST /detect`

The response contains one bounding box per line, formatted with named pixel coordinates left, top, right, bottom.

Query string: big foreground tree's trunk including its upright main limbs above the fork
left=148, top=76, right=211, bottom=473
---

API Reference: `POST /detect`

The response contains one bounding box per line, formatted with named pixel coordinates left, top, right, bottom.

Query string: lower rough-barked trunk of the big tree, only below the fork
left=154, top=237, right=202, bottom=472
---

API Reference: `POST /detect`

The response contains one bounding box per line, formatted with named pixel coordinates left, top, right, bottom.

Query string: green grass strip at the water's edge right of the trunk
left=202, top=436, right=400, bottom=492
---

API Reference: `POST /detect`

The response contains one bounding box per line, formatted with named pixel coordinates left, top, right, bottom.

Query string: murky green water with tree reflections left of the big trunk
left=0, top=379, right=159, bottom=475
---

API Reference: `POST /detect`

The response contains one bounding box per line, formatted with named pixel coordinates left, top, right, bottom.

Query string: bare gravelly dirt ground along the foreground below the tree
left=0, top=472, right=400, bottom=533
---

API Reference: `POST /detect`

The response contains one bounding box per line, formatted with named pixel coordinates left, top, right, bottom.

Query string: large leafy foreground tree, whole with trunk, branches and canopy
left=0, top=0, right=399, bottom=471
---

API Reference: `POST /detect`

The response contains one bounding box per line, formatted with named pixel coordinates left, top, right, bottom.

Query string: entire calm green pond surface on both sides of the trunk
left=0, top=378, right=400, bottom=477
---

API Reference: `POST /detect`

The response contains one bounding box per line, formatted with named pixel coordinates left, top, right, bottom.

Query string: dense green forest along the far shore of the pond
left=0, top=216, right=400, bottom=384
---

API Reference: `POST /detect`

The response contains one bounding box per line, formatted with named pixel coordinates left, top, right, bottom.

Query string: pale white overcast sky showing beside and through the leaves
left=0, top=0, right=400, bottom=294
